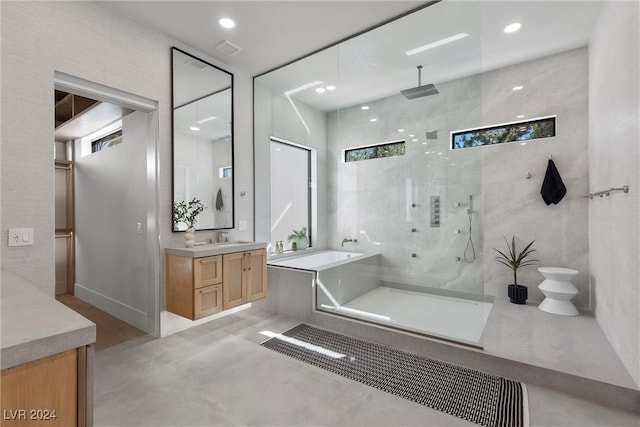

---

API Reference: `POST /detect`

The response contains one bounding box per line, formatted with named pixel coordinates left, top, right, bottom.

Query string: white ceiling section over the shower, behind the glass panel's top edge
left=258, top=0, right=601, bottom=111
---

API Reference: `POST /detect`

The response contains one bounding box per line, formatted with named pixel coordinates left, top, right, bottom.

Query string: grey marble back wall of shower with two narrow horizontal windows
left=327, top=48, right=589, bottom=308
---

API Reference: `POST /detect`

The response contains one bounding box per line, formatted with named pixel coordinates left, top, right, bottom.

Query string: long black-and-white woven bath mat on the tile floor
left=262, top=324, right=529, bottom=427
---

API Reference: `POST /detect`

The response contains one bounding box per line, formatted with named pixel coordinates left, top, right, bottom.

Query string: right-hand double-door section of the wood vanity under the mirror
left=222, top=249, right=267, bottom=310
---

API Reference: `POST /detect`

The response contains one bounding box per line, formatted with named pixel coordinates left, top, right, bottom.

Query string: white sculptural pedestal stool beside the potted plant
left=538, top=267, right=579, bottom=316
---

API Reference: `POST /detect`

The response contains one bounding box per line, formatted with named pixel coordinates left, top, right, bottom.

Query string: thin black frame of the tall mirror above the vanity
left=170, top=46, right=236, bottom=233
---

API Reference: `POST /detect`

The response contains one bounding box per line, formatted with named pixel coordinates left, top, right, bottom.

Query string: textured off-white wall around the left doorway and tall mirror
left=0, top=2, right=253, bottom=338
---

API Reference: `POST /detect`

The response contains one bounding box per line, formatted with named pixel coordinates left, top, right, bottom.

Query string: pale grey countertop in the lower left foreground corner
left=0, top=270, right=96, bottom=369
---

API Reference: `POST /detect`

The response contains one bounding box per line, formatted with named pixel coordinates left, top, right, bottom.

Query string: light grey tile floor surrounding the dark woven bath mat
left=94, top=308, right=640, bottom=427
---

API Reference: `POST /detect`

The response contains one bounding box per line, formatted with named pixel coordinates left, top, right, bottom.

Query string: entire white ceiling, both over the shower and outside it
left=99, top=0, right=601, bottom=111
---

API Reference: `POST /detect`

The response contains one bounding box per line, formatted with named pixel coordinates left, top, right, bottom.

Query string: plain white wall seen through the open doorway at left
left=75, top=112, right=153, bottom=331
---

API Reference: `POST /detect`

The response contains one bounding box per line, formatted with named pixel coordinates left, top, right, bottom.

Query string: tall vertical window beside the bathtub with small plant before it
left=271, top=138, right=315, bottom=253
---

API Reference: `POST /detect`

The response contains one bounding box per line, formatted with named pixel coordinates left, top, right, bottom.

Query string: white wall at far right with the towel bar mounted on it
left=589, top=1, right=640, bottom=384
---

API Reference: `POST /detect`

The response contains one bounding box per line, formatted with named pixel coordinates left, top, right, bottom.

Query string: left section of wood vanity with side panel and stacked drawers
left=165, top=255, right=222, bottom=320
